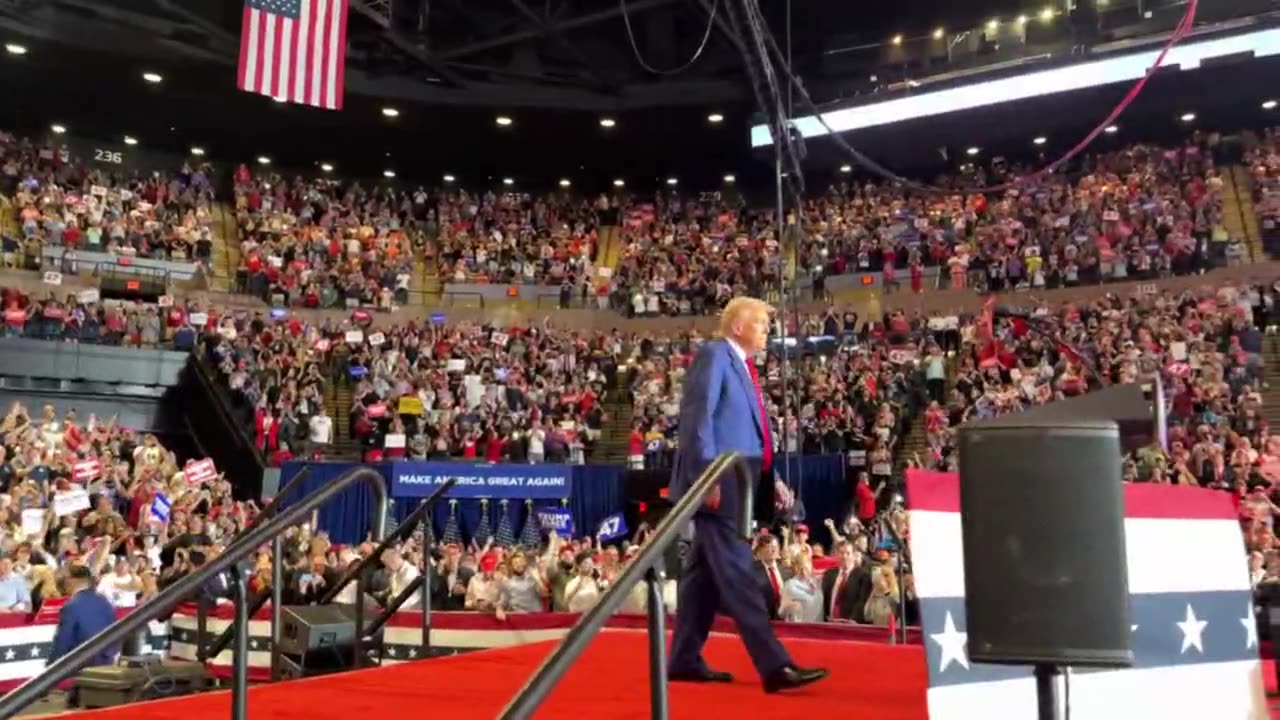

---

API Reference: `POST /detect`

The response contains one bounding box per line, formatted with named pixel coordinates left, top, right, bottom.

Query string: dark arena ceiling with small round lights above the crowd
left=0, top=0, right=1275, bottom=188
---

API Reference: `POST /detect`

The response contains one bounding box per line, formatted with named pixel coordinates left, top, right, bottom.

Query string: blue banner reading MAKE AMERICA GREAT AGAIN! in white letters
left=392, top=461, right=572, bottom=500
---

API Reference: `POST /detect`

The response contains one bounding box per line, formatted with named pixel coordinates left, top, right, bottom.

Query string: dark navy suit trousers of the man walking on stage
left=669, top=515, right=791, bottom=679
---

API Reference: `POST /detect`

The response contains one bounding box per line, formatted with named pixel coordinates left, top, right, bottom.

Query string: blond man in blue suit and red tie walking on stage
left=668, top=297, right=827, bottom=693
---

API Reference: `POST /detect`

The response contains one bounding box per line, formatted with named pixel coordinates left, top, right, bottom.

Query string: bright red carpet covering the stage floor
left=55, top=630, right=928, bottom=720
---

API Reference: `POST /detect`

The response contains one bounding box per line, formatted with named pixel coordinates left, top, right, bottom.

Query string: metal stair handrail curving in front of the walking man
left=498, top=452, right=759, bottom=720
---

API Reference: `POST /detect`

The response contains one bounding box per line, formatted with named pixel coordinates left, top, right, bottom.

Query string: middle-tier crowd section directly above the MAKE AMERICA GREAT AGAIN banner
left=206, top=302, right=621, bottom=464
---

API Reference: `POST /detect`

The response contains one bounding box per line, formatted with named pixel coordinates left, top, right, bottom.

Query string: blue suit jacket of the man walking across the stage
left=669, top=340, right=765, bottom=524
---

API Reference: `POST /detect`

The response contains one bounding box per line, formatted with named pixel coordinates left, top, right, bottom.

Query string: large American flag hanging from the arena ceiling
left=237, top=0, right=347, bottom=110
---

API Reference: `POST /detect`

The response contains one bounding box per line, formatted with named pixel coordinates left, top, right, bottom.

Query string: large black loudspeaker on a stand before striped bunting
left=959, top=418, right=1133, bottom=667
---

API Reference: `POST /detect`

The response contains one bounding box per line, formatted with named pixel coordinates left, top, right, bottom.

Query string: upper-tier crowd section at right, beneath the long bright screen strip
left=799, top=133, right=1245, bottom=292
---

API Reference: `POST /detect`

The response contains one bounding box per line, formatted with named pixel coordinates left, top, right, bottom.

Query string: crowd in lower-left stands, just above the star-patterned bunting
left=0, top=402, right=249, bottom=616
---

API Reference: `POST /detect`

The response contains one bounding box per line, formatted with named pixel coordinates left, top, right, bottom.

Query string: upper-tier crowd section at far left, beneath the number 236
left=0, top=128, right=214, bottom=273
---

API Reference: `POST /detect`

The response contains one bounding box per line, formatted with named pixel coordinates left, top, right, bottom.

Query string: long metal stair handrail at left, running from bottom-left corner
left=0, top=468, right=387, bottom=720
